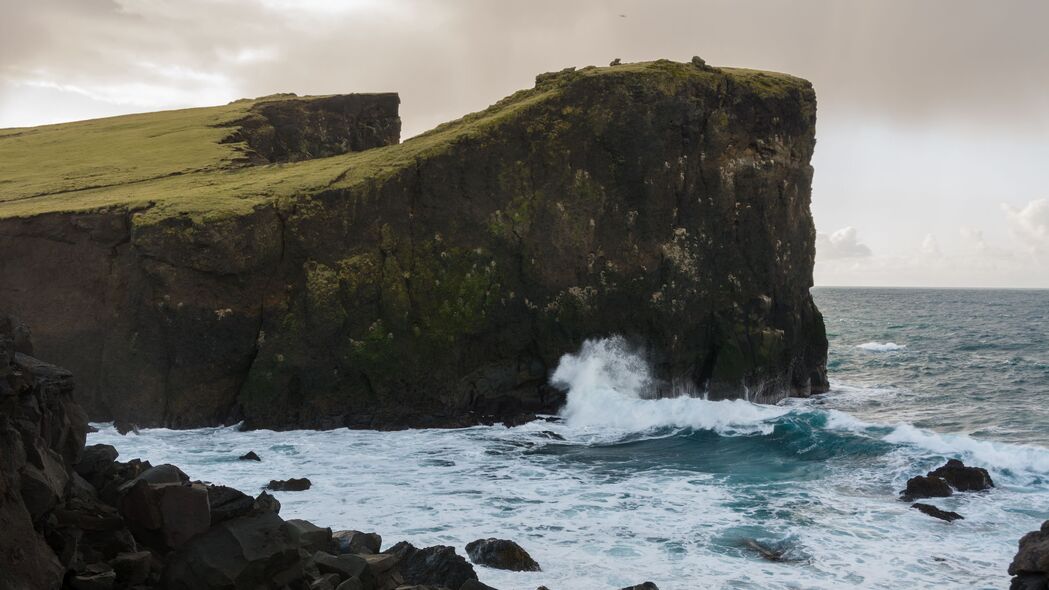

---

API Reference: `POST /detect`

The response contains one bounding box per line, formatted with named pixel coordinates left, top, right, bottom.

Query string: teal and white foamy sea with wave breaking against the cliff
left=88, top=289, right=1049, bottom=590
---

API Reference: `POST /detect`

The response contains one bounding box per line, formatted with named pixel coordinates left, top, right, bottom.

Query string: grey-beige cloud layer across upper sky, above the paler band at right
left=0, top=0, right=1049, bottom=132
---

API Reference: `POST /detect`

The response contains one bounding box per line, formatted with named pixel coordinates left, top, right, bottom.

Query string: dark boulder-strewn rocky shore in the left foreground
left=0, top=317, right=656, bottom=590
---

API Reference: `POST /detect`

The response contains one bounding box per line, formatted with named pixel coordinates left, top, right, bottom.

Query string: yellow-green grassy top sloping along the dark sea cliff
left=0, top=60, right=809, bottom=222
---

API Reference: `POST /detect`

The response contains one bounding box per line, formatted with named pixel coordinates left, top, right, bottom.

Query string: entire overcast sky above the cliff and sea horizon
left=0, top=0, right=1049, bottom=288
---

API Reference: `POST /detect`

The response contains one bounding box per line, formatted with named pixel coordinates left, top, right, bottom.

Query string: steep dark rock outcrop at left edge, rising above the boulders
left=0, top=315, right=87, bottom=590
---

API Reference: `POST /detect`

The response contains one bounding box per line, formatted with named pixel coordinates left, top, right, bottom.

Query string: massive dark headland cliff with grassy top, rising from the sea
left=0, top=61, right=827, bottom=427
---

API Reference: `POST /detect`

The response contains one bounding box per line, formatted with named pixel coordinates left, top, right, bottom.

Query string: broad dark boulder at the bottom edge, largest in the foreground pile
left=164, top=512, right=303, bottom=590
